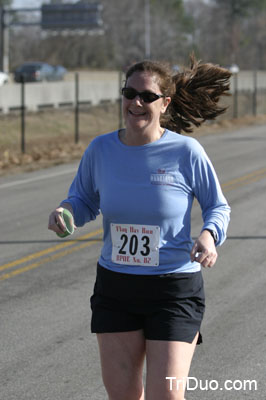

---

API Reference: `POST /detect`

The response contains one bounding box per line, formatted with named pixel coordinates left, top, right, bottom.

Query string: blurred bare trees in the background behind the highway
left=0, top=0, right=266, bottom=71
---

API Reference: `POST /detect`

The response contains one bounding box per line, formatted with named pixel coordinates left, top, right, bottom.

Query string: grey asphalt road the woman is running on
left=0, top=126, right=266, bottom=400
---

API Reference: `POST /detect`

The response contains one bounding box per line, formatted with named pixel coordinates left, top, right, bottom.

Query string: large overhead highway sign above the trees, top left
left=41, top=3, right=103, bottom=30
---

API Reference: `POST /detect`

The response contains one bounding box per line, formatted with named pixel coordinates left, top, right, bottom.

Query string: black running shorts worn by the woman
left=91, top=264, right=205, bottom=344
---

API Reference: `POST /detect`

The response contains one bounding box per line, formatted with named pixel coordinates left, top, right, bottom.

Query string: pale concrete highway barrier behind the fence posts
left=0, top=71, right=266, bottom=114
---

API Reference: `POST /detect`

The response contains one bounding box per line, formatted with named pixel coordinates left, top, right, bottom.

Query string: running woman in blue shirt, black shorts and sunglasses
left=49, top=57, right=230, bottom=400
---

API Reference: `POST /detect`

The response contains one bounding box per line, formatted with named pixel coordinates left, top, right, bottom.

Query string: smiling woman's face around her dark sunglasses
left=123, top=71, right=170, bottom=132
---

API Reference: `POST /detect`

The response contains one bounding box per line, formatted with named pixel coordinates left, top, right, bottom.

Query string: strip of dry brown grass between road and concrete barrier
left=0, top=104, right=266, bottom=175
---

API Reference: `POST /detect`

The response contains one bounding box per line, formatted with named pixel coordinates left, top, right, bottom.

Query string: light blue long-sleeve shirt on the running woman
left=62, top=130, right=230, bottom=274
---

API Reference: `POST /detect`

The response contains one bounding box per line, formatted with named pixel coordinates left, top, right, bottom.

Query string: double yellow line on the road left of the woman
left=0, top=229, right=103, bottom=271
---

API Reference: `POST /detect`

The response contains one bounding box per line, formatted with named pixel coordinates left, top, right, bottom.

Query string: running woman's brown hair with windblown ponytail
left=126, top=55, right=231, bottom=133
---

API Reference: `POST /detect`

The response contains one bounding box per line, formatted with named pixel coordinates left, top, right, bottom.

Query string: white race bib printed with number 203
left=111, top=224, right=160, bottom=267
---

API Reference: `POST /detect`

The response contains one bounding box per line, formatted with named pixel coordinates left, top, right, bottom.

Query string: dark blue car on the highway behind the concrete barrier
left=14, top=62, right=66, bottom=82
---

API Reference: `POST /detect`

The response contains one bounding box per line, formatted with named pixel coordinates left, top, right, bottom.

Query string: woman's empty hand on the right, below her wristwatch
left=190, top=230, right=218, bottom=268
